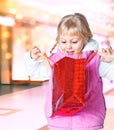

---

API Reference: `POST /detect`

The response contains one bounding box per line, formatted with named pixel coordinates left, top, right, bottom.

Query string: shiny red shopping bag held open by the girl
left=52, top=57, right=86, bottom=116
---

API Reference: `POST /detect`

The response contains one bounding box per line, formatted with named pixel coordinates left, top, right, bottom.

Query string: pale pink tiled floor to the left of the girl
left=0, top=83, right=47, bottom=130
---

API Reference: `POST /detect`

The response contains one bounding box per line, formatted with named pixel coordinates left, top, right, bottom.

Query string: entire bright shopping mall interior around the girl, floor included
left=0, top=0, right=114, bottom=130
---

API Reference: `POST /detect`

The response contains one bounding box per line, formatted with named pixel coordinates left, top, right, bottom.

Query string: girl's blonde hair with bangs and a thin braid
left=51, top=13, right=93, bottom=52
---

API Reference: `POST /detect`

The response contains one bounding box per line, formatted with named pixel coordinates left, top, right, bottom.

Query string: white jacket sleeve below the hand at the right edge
left=99, top=61, right=114, bottom=81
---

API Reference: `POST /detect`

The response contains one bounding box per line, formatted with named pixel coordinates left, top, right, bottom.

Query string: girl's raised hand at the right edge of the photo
left=97, top=46, right=114, bottom=62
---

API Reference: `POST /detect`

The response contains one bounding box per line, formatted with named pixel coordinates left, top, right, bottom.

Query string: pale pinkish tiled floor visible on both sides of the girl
left=0, top=81, right=114, bottom=130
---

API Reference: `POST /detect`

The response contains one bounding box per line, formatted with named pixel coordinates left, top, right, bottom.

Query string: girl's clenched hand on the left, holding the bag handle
left=30, top=46, right=42, bottom=59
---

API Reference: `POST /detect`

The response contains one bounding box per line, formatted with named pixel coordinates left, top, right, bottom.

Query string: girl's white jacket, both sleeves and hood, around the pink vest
left=24, top=39, right=114, bottom=81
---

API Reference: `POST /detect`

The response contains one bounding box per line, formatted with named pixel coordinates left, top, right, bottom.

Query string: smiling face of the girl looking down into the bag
left=58, top=35, right=84, bottom=54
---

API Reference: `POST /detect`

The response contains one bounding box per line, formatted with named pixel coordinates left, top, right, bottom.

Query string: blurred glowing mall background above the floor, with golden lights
left=0, top=0, right=114, bottom=84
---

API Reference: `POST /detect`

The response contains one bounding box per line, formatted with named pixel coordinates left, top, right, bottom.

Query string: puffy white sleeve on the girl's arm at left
left=24, top=51, right=51, bottom=80
